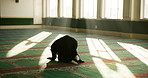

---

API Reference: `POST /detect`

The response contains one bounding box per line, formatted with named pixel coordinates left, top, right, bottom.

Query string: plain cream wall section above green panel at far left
left=1, top=0, right=34, bottom=18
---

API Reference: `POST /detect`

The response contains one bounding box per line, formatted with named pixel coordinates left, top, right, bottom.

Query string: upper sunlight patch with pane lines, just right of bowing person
left=86, top=38, right=121, bottom=61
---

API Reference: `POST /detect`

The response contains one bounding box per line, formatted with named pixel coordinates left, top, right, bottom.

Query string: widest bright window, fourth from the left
left=103, top=0, right=123, bottom=19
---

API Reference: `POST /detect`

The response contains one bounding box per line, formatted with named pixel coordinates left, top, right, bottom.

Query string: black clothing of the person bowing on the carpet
left=51, top=35, right=78, bottom=62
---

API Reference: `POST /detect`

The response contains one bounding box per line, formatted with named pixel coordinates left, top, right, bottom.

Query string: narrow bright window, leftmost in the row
left=47, top=0, right=58, bottom=17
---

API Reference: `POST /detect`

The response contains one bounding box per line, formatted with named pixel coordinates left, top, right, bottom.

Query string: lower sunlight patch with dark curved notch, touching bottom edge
left=92, top=58, right=136, bottom=78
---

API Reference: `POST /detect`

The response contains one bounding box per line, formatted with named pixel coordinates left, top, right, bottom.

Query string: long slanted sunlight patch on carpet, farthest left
left=6, top=31, right=52, bottom=57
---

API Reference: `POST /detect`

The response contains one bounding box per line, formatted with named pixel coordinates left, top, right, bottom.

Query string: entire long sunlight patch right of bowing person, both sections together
left=86, top=38, right=136, bottom=78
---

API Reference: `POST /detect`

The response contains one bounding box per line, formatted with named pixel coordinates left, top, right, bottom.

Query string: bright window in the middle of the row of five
left=81, top=0, right=97, bottom=18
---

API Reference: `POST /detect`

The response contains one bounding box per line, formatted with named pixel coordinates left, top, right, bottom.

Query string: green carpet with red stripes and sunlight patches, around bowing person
left=0, top=29, right=148, bottom=78
